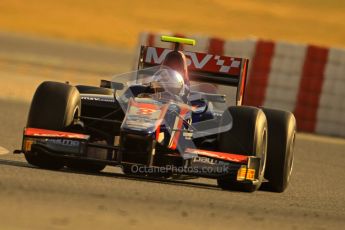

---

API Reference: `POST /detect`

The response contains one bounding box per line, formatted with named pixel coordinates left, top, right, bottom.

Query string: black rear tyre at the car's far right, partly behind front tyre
left=262, top=108, right=296, bottom=192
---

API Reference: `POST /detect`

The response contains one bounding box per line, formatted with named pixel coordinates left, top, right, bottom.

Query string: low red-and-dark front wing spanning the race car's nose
left=19, top=128, right=260, bottom=183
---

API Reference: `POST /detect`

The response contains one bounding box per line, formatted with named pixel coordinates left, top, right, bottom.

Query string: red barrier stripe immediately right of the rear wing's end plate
left=244, top=40, right=275, bottom=106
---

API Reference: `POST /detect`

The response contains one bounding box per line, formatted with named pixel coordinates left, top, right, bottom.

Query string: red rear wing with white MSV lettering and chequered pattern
left=138, top=46, right=249, bottom=105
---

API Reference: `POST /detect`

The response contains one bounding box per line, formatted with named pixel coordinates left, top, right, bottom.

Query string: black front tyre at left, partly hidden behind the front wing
left=25, top=81, right=81, bottom=169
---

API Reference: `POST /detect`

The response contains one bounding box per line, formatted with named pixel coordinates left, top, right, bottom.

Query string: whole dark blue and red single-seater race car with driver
left=16, top=36, right=296, bottom=192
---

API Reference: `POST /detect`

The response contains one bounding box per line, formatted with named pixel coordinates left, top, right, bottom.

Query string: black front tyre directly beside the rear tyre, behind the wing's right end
left=218, top=106, right=268, bottom=192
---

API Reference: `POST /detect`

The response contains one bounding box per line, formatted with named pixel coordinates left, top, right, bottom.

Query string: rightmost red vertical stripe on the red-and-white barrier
left=295, top=46, right=329, bottom=132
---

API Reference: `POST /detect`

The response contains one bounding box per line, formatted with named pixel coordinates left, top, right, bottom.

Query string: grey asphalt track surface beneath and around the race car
left=0, top=31, right=345, bottom=229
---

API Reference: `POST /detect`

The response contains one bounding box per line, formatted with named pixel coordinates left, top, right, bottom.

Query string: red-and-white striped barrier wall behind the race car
left=136, top=32, right=345, bottom=137
